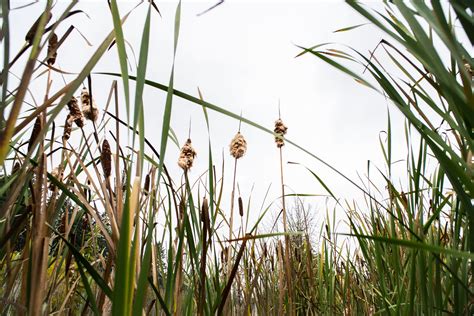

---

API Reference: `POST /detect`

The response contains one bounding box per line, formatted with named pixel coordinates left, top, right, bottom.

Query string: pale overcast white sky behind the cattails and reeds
left=11, top=0, right=414, bottom=237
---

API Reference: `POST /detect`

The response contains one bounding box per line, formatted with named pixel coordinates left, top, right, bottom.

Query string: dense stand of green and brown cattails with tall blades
left=0, top=1, right=474, bottom=315
